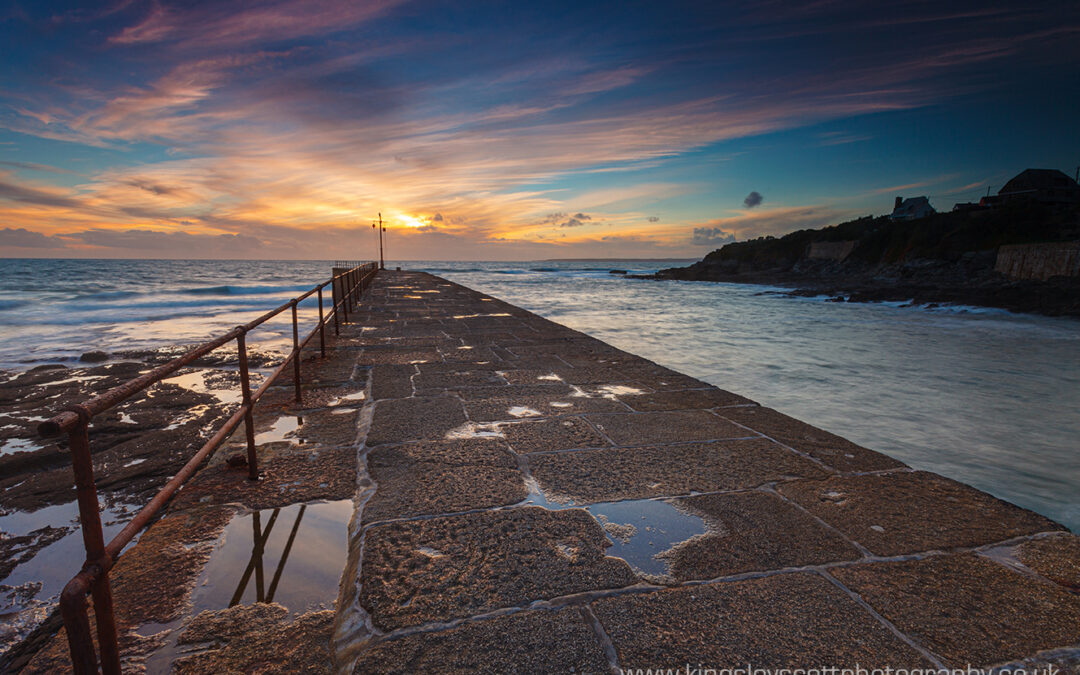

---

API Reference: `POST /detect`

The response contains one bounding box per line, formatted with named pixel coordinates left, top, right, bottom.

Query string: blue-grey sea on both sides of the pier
left=0, top=259, right=1080, bottom=532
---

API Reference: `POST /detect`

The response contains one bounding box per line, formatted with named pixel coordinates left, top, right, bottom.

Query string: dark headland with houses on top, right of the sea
left=649, top=168, right=1080, bottom=316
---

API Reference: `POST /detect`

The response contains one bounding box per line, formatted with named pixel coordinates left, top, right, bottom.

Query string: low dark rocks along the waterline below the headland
left=643, top=254, right=1080, bottom=316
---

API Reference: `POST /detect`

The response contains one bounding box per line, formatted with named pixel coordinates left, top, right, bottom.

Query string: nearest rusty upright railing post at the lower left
left=68, top=405, right=120, bottom=675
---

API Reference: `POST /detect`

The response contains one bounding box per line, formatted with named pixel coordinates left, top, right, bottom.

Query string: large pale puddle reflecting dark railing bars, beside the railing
left=136, top=499, right=354, bottom=673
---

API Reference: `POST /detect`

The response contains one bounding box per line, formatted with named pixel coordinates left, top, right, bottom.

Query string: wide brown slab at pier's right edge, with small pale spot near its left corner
left=778, top=471, right=1063, bottom=555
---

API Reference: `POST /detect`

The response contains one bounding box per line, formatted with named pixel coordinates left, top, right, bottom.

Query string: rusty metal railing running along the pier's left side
left=38, top=262, right=378, bottom=675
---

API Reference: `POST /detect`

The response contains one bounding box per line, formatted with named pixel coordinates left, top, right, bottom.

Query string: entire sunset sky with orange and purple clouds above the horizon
left=0, top=0, right=1080, bottom=260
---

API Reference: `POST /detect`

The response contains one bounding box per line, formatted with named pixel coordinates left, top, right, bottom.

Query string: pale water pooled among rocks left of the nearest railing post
left=0, top=501, right=137, bottom=653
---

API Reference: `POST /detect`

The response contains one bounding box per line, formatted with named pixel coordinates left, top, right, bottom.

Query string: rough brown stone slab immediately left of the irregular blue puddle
left=360, top=507, right=637, bottom=630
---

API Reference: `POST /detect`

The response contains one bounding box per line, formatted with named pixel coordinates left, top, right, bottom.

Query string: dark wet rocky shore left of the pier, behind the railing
left=0, top=347, right=280, bottom=671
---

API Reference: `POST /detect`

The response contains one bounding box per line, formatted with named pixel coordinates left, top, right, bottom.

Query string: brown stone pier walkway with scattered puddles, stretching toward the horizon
left=16, top=272, right=1080, bottom=673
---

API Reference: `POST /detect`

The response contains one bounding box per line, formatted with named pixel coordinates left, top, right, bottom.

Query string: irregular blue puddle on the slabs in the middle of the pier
left=519, top=478, right=708, bottom=577
